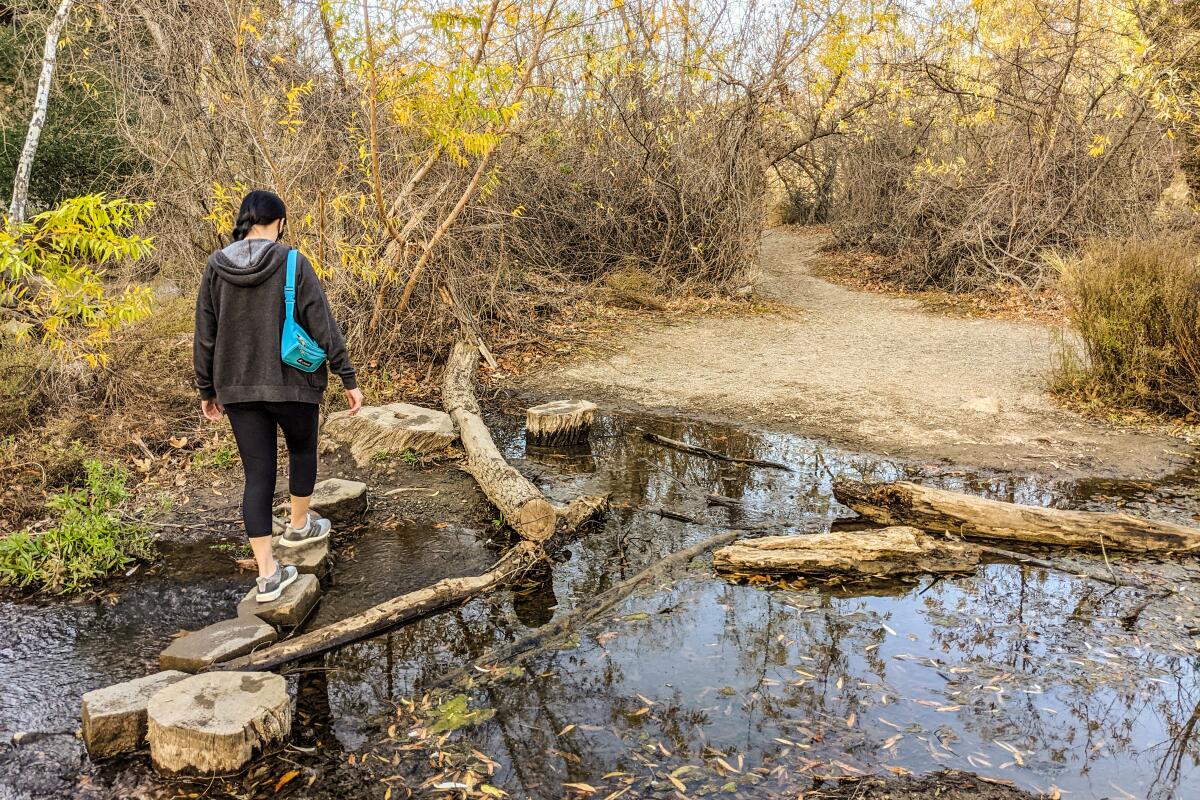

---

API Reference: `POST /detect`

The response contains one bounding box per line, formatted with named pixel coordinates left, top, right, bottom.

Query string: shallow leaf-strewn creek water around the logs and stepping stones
left=0, top=416, right=1200, bottom=799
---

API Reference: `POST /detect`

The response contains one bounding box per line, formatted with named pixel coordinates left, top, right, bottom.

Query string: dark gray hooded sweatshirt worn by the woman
left=192, top=239, right=358, bottom=405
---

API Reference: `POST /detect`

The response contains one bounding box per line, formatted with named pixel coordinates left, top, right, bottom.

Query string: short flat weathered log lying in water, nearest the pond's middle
left=713, top=525, right=979, bottom=577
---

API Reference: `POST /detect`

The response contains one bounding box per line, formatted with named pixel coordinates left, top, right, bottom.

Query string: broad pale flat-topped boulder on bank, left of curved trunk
left=322, top=403, right=458, bottom=467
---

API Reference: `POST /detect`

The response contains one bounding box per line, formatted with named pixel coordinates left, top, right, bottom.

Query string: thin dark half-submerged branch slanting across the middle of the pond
left=436, top=530, right=746, bottom=686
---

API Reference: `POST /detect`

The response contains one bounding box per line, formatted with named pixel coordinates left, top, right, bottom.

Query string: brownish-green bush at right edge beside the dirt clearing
left=1055, top=236, right=1200, bottom=414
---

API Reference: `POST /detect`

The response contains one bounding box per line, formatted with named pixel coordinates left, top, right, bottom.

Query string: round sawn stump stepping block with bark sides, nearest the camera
left=146, top=672, right=292, bottom=775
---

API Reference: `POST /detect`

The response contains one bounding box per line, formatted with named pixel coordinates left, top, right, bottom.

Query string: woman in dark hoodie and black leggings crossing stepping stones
left=192, top=191, right=362, bottom=602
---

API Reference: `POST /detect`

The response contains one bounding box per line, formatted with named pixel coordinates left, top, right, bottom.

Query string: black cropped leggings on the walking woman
left=224, top=402, right=320, bottom=539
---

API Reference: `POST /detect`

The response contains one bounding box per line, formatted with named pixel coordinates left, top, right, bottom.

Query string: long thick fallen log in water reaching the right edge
left=833, top=477, right=1200, bottom=553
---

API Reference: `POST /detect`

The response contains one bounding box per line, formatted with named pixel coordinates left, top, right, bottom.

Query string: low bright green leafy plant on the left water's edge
left=0, top=461, right=154, bottom=593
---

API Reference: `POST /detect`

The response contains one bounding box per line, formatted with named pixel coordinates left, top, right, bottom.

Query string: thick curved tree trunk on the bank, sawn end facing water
left=442, top=342, right=558, bottom=542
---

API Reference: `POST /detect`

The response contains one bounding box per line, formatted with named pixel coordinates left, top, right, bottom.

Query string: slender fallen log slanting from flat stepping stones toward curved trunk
left=214, top=542, right=542, bottom=670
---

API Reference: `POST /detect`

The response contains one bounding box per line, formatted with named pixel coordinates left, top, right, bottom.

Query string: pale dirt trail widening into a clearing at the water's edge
left=527, top=230, right=1189, bottom=479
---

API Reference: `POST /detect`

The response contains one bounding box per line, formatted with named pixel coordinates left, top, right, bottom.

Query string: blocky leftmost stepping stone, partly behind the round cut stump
left=80, top=669, right=187, bottom=758
